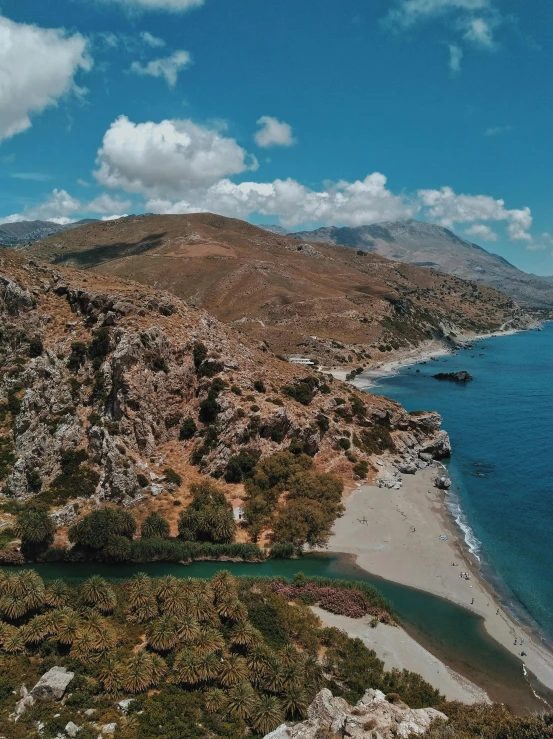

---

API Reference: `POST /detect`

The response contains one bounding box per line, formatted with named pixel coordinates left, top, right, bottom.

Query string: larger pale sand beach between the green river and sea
left=328, top=467, right=553, bottom=689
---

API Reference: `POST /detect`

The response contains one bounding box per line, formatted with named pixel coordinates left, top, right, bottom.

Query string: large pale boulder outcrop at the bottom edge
left=266, top=688, right=447, bottom=739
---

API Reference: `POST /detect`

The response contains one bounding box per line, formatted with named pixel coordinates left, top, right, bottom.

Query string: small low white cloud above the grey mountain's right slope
left=418, top=187, right=532, bottom=242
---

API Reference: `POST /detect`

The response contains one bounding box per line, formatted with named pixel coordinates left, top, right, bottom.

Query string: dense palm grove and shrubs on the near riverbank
left=0, top=570, right=441, bottom=739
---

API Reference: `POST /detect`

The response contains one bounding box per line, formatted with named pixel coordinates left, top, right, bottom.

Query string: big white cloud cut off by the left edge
left=0, top=16, right=92, bottom=141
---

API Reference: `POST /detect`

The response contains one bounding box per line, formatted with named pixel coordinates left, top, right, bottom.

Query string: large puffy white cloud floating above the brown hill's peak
left=94, top=116, right=257, bottom=199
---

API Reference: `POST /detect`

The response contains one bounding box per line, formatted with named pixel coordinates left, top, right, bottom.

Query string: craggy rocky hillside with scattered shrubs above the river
left=0, top=250, right=449, bottom=526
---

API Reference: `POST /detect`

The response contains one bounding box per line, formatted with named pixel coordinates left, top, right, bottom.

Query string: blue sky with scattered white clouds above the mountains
left=0, top=0, right=553, bottom=274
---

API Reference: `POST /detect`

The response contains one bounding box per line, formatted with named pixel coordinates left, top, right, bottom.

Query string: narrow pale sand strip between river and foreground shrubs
left=312, top=606, right=489, bottom=703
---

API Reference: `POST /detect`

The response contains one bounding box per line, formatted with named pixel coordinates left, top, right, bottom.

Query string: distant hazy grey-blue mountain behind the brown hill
left=289, top=220, right=553, bottom=310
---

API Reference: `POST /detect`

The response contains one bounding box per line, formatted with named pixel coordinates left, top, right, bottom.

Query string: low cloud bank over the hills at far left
left=0, top=189, right=131, bottom=225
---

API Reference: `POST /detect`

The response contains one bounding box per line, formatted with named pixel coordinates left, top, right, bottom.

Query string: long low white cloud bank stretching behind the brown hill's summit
left=146, top=172, right=419, bottom=228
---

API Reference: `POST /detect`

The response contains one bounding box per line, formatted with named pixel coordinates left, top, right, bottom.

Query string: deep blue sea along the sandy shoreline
left=370, top=323, right=553, bottom=638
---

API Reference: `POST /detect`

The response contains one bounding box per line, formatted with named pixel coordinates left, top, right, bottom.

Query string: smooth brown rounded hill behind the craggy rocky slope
left=22, top=213, right=526, bottom=366
